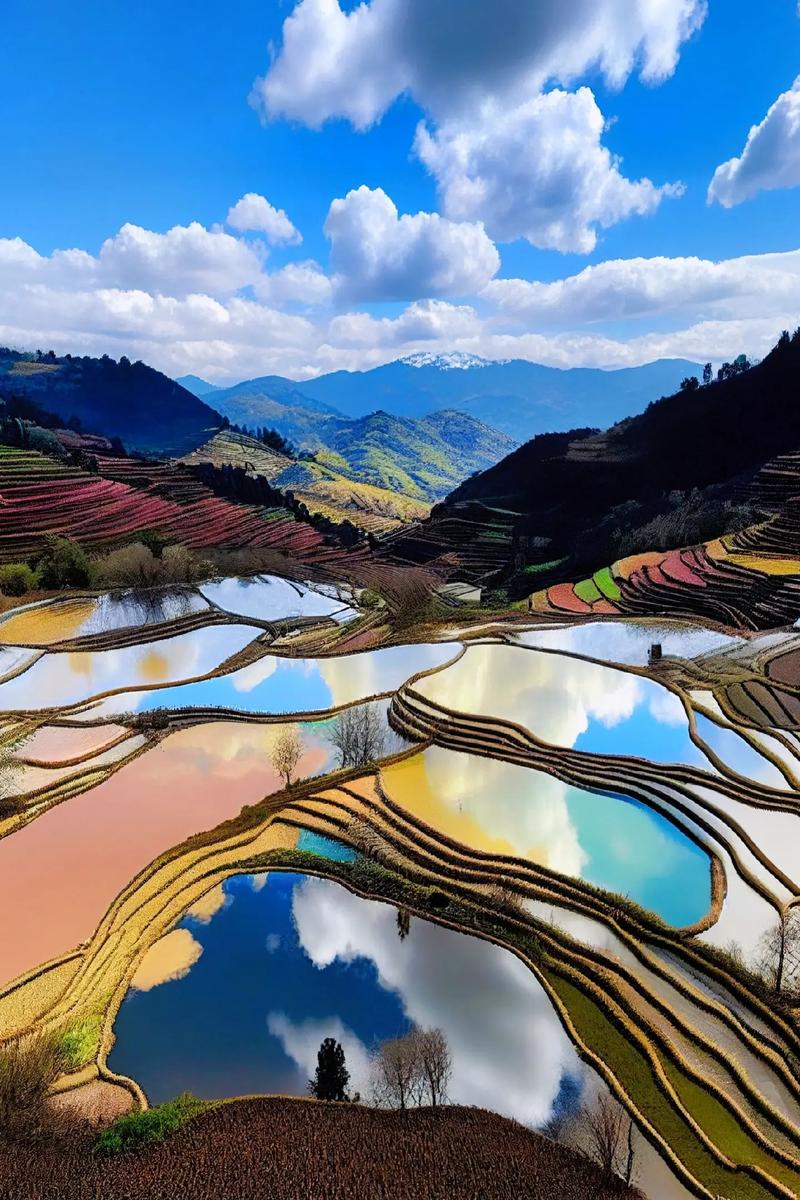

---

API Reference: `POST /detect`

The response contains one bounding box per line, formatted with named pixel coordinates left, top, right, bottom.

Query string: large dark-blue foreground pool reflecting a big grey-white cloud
left=109, top=874, right=583, bottom=1124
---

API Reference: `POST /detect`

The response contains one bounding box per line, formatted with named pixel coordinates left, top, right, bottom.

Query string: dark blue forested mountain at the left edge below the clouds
left=0, top=348, right=221, bottom=455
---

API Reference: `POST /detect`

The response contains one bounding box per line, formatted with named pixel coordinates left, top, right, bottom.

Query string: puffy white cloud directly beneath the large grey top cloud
left=415, top=88, right=678, bottom=253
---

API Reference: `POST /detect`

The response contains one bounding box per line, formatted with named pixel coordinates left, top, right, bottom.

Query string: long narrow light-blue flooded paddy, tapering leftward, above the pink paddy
left=91, top=644, right=455, bottom=715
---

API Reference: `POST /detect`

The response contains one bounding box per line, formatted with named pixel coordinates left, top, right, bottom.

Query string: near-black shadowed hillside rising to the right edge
left=391, top=331, right=800, bottom=594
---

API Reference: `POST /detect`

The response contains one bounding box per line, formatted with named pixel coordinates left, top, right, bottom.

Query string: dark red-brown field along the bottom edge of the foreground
left=0, top=1098, right=637, bottom=1200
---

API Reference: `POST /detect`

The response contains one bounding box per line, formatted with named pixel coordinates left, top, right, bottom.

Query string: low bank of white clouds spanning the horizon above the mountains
left=0, top=218, right=800, bottom=383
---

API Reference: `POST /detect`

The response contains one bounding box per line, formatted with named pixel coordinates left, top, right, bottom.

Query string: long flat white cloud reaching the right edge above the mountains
left=482, top=251, right=800, bottom=326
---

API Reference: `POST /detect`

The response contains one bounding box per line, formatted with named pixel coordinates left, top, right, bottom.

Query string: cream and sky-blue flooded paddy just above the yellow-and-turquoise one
left=416, top=646, right=705, bottom=763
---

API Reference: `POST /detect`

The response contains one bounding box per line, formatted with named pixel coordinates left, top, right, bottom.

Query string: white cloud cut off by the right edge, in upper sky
left=708, top=76, right=800, bottom=209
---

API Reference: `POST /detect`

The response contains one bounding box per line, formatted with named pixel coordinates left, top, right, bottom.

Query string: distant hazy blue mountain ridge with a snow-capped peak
left=181, top=352, right=700, bottom=442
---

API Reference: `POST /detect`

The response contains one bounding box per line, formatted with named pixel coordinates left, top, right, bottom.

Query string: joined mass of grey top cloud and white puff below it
left=253, top=0, right=706, bottom=253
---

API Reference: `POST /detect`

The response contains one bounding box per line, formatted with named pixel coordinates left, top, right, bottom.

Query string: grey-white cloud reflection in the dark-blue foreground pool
left=291, top=878, right=583, bottom=1126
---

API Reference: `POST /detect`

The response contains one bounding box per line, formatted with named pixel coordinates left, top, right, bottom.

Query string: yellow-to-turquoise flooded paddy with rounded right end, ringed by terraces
left=384, top=746, right=710, bottom=925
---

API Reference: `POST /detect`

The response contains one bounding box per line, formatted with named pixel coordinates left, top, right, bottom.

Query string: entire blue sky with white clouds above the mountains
left=0, top=0, right=800, bottom=383
